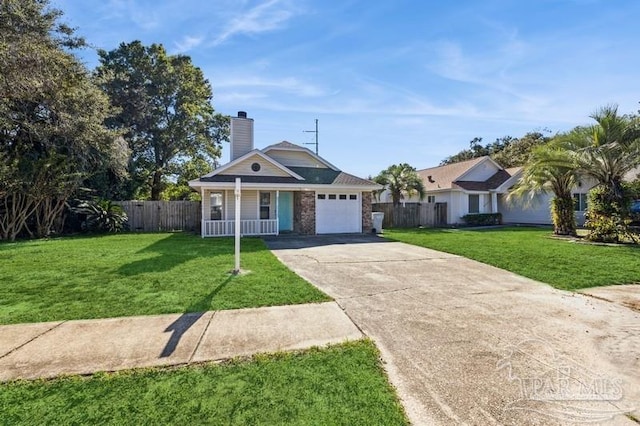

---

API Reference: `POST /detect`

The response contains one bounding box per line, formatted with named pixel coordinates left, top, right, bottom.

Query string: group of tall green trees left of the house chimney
left=0, top=0, right=229, bottom=240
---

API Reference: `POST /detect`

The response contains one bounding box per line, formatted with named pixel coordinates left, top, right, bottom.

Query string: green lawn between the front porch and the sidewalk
left=0, top=233, right=329, bottom=324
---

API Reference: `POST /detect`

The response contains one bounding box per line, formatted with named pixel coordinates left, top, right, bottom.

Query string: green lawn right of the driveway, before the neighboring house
left=384, top=227, right=640, bottom=290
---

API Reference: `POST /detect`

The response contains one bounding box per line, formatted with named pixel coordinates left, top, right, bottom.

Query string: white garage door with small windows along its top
left=316, top=192, right=362, bottom=234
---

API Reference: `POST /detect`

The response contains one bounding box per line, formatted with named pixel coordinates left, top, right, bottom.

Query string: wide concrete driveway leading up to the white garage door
left=267, top=236, right=640, bottom=425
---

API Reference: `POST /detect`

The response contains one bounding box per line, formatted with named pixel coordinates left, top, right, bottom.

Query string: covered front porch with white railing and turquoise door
left=201, top=189, right=294, bottom=237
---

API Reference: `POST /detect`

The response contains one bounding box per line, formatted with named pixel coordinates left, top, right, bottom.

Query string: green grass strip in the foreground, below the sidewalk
left=0, top=340, right=408, bottom=425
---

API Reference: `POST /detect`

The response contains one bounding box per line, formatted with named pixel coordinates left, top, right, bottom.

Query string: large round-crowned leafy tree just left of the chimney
left=95, top=41, right=228, bottom=200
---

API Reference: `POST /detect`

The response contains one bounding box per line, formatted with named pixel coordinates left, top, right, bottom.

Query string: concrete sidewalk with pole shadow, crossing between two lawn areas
left=0, top=302, right=363, bottom=381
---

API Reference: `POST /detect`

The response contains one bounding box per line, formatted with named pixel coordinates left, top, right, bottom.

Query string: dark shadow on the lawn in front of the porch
left=118, top=233, right=266, bottom=276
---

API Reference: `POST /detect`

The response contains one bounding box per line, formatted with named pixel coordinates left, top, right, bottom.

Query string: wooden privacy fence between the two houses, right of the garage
left=372, top=203, right=447, bottom=228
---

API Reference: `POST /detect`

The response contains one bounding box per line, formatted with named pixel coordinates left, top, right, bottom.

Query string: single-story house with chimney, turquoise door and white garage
left=189, top=111, right=380, bottom=237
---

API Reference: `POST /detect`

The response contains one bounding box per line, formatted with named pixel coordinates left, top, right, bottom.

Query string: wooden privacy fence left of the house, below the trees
left=114, top=201, right=202, bottom=232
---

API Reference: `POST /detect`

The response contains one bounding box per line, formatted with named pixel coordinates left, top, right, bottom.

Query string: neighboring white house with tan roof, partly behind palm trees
left=381, top=156, right=595, bottom=225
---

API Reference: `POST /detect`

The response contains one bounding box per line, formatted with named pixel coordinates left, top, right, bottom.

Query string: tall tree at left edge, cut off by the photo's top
left=0, top=0, right=127, bottom=240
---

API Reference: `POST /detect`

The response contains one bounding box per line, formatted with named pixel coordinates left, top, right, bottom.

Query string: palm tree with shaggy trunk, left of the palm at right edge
left=507, top=143, right=578, bottom=236
